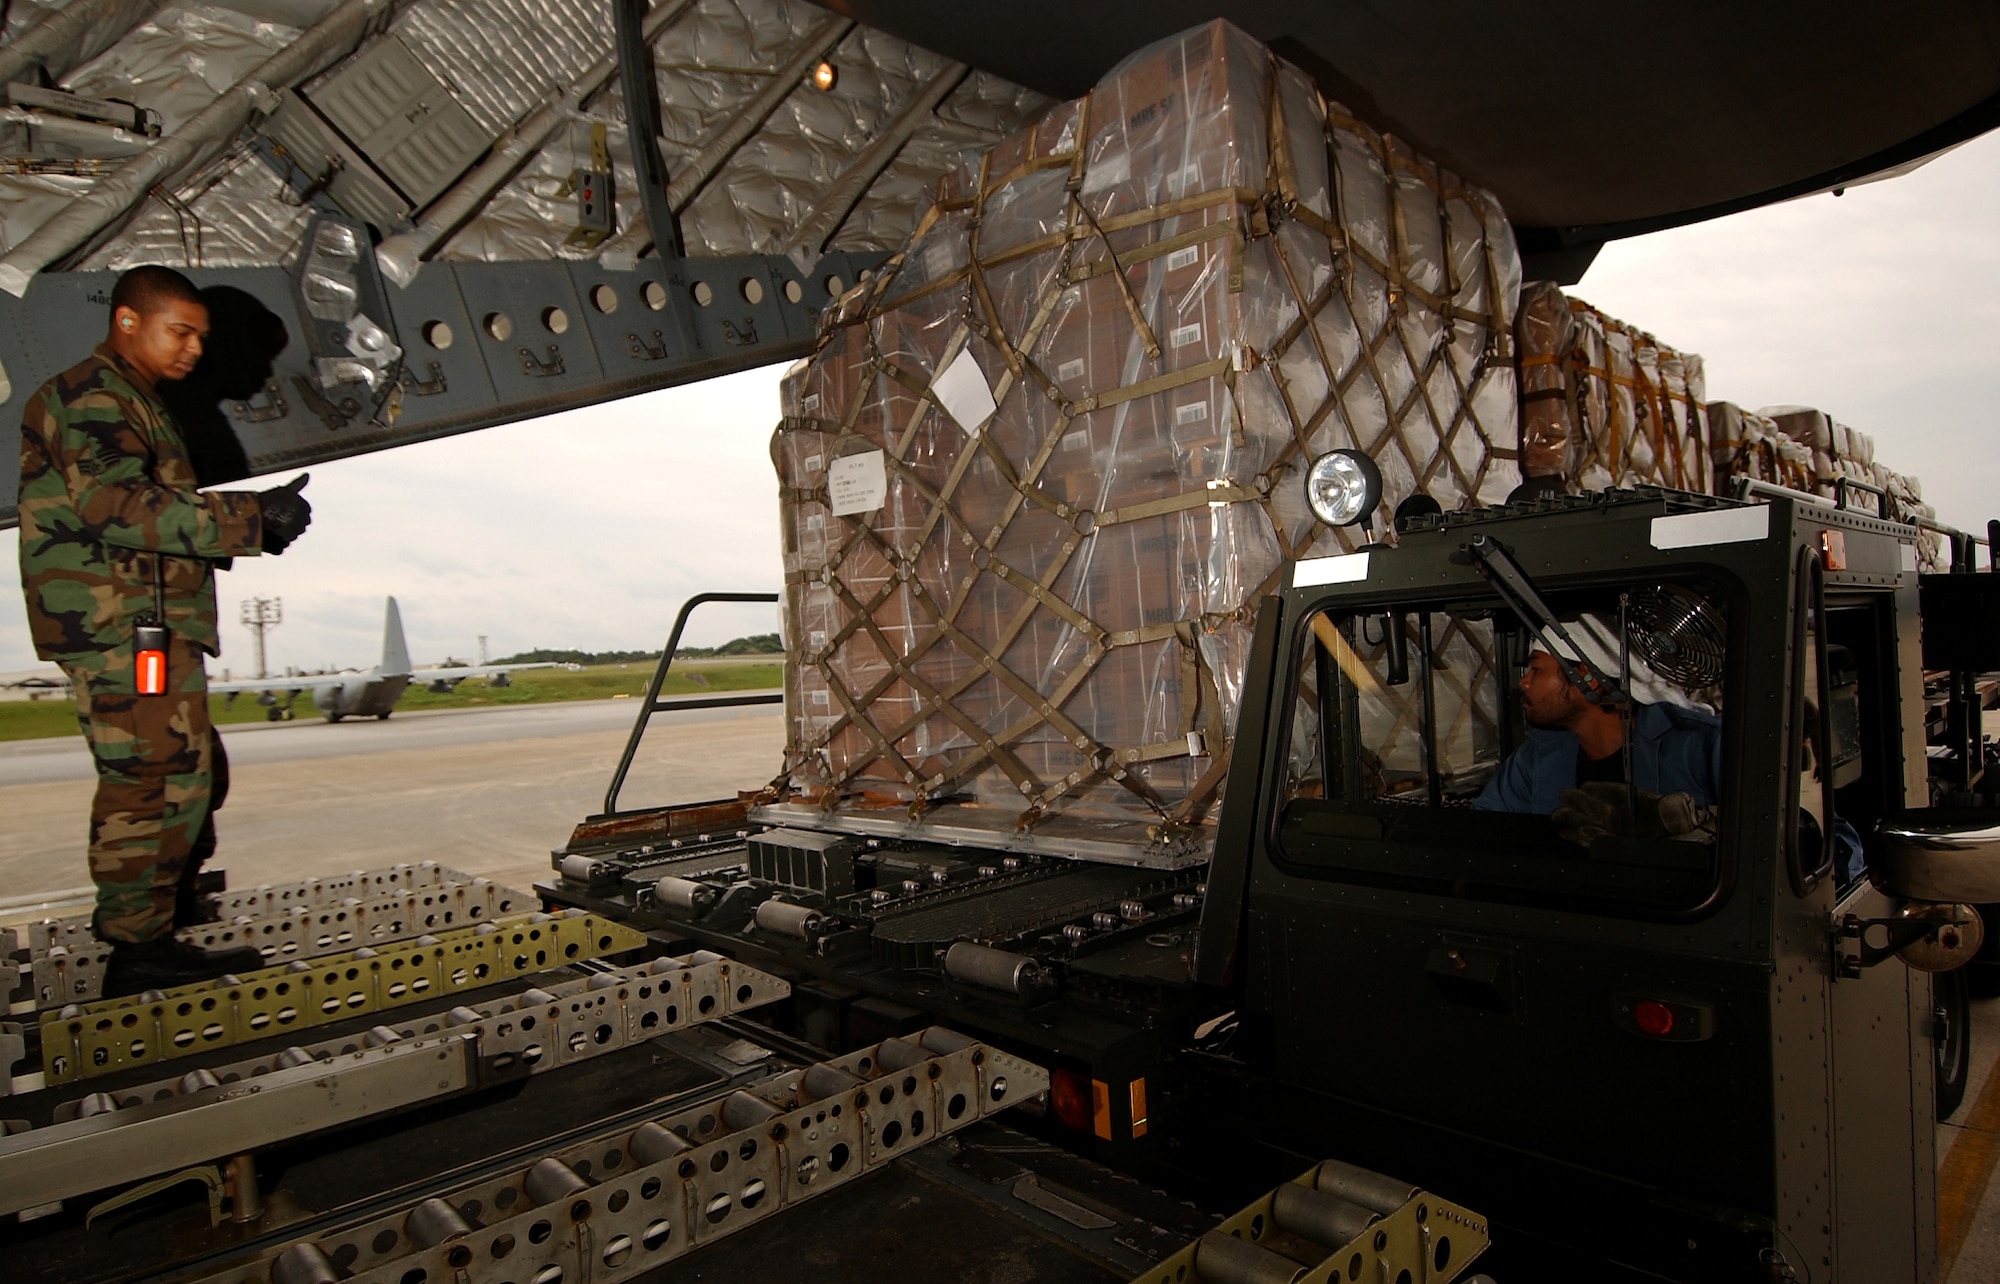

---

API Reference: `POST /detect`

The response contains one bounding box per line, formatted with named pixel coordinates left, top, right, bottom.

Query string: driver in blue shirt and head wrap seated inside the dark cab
left=1472, top=650, right=1722, bottom=816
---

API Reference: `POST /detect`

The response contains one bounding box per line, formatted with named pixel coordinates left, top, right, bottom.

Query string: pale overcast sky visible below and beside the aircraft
left=0, top=125, right=2000, bottom=674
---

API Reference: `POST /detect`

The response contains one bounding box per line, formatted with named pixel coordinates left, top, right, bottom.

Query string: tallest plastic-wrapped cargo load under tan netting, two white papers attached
left=772, top=22, right=1520, bottom=860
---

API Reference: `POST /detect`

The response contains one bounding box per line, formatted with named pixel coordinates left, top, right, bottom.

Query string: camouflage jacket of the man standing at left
left=20, top=344, right=264, bottom=662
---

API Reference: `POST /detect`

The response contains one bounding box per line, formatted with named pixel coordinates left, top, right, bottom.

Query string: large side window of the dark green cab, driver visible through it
left=1274, top=582, right=1728, bottom=914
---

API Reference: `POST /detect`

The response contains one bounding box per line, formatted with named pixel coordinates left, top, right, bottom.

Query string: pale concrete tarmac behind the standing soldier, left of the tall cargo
left=0, top=700, right=784, bottom=904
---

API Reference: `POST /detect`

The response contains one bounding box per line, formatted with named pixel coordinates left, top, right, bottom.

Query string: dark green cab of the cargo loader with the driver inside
left=1196, top=490, right=1992, bottom=1280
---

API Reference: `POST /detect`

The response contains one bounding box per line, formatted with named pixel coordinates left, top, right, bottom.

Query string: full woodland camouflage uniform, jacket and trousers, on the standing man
left=20, top=344, right=262, bottom=942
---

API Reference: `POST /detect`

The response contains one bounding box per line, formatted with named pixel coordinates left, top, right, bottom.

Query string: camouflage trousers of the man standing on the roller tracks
left=64, top=634, right=226, bottom=942
